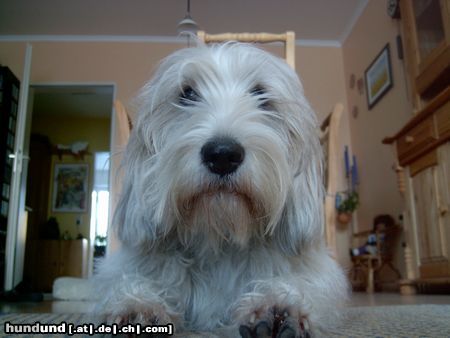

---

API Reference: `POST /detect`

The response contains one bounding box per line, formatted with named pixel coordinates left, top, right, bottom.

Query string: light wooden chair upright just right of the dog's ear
left=320, top=103, right=344, bottom=256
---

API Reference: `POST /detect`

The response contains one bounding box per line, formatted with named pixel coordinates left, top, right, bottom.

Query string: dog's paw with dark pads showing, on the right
left=239, top=307, right=311, bottom=338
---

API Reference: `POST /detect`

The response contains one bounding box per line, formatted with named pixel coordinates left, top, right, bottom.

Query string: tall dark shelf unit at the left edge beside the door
left=0, top=65, right=20, bottom=290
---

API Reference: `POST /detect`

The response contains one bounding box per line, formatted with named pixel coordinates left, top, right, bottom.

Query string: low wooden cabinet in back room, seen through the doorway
left=32, top=239, right=88, bottom=292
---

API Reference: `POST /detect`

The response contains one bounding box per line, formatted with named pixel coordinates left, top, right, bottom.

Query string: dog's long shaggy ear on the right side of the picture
left=274, top=96, right=324, bottom=255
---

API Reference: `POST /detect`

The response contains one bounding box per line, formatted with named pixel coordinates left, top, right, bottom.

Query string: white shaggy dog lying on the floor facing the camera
left=97, top=43, right=347, bottom=338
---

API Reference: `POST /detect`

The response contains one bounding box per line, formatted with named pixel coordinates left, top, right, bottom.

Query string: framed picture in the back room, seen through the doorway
left=52, top=163, right=89, bottom=212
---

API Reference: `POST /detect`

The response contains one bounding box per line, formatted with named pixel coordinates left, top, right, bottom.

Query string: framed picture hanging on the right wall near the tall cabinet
left=364, top=44, right=393, bottom=109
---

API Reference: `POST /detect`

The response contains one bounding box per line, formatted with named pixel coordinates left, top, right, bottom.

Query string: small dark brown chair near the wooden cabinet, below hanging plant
left=350, top=215, right=402, bottom=293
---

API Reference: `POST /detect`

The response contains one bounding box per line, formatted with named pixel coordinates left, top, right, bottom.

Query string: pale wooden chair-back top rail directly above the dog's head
left=197, top=31, right=295, bottom=70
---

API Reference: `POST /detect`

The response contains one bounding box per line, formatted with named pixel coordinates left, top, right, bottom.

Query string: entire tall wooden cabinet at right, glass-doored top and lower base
left=383, top=0, right=450, bottom=293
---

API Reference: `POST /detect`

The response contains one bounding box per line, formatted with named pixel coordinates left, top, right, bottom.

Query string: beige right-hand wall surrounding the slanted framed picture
left=342, top=0, right=412, bottom=278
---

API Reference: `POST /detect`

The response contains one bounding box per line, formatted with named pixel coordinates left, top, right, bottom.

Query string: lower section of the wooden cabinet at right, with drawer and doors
left=383, top=87, right=450, bottom=292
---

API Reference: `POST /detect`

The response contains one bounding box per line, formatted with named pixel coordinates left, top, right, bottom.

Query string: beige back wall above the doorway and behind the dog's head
left=0, top=42, right=346, bottom=120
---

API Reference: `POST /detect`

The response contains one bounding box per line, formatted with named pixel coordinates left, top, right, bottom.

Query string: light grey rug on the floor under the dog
left=0, top=305, right=450, bottom=338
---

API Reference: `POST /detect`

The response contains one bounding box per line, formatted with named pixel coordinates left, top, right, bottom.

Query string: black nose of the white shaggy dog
left=201, top=137, right=245, bottom=176
